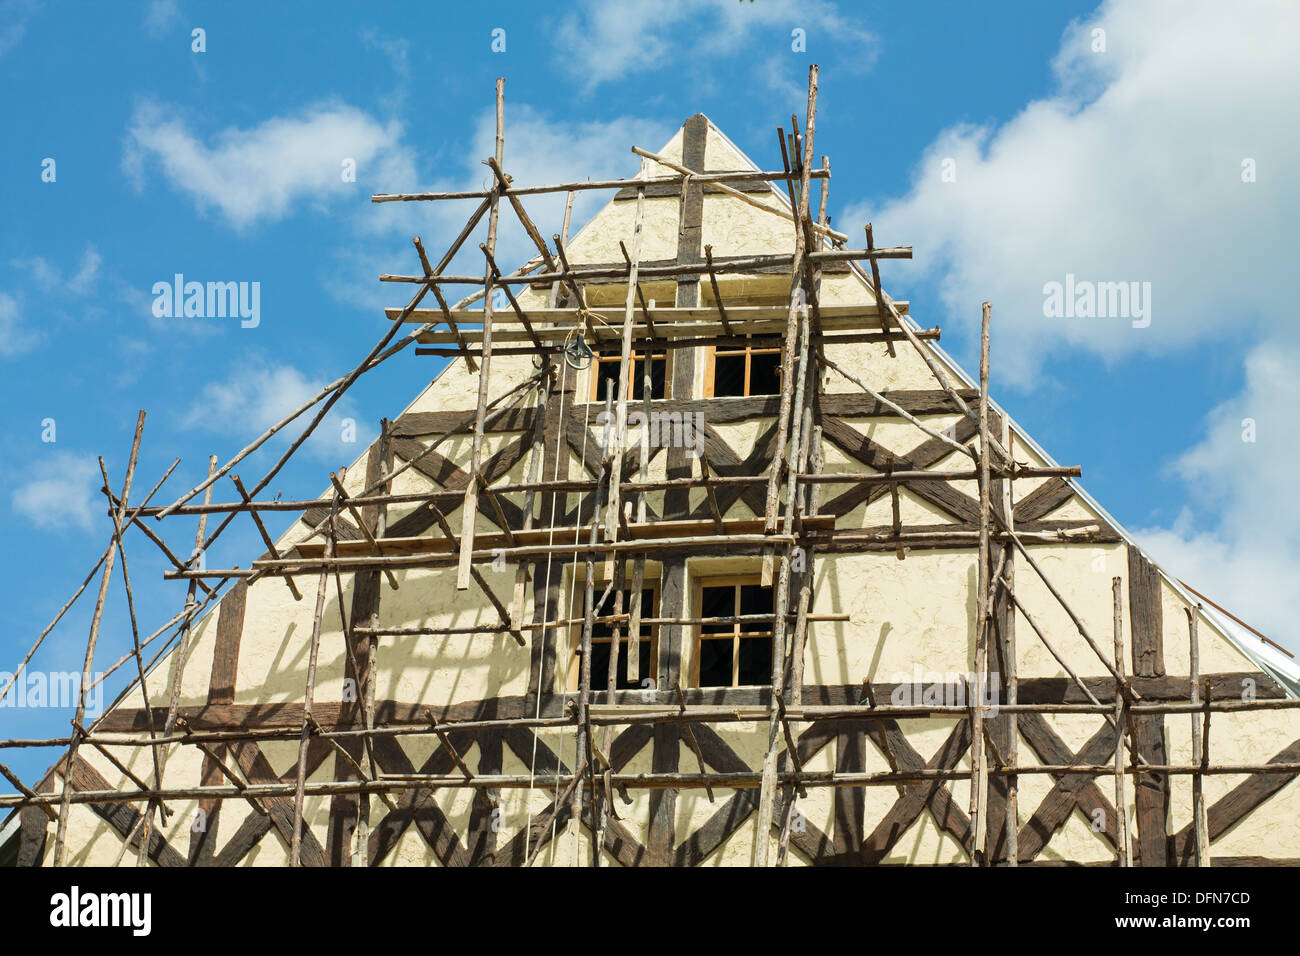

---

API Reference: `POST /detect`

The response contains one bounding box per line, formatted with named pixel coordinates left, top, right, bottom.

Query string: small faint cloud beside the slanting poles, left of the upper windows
left=179, top=354, right=373, bottom=466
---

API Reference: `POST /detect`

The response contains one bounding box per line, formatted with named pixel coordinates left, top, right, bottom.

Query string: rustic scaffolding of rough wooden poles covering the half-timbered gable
left=0, top=66, right=1300, bottom=865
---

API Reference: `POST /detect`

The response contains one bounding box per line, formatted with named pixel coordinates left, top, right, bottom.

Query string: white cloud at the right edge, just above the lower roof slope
left=1139, top=342, right=1300, bottom=652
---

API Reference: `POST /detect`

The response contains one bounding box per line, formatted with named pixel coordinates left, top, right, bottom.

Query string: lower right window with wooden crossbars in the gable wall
left=693, top=576, right=772, bottom=687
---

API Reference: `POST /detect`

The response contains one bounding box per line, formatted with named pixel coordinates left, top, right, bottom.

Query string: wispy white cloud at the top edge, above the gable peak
left=555, top=0, right=876, bottom=91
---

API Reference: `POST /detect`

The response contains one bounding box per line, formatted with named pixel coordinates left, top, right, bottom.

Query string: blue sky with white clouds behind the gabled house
left=0, top=0, right=1300, bottom=774
